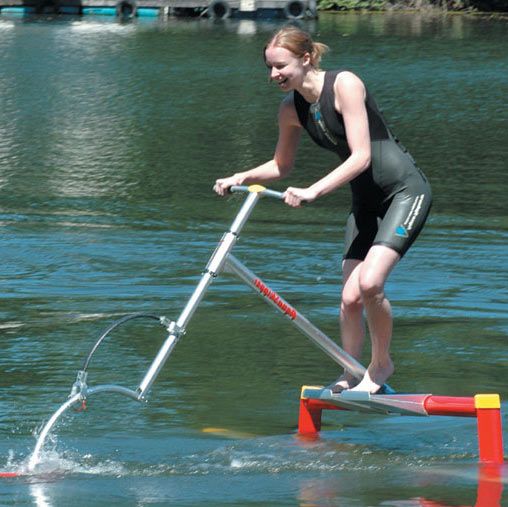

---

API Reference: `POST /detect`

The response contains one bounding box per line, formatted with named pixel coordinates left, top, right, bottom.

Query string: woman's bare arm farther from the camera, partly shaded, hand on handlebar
left=214, top=94, right=302, bottom=195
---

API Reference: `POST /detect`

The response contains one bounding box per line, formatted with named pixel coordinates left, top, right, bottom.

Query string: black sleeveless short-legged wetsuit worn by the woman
left=294, top=70, right=432, bottom=260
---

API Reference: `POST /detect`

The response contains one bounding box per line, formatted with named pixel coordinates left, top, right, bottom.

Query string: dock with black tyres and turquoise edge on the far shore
left=0, top=0, right=317, bottom=20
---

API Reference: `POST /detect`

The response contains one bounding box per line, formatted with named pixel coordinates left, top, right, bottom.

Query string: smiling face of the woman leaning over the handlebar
left=265, top=45, right=312, bottom=92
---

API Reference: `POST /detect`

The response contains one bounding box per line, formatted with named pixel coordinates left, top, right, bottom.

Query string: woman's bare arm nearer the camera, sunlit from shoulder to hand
left=286, top=72, right=371, bottom=206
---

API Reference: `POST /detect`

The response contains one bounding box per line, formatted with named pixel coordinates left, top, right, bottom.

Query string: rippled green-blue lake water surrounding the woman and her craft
left=0, top=14, right=508, bottom=507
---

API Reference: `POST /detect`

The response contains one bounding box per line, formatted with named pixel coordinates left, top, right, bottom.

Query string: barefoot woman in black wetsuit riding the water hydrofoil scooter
left=214, top=26, right=432, bottom=393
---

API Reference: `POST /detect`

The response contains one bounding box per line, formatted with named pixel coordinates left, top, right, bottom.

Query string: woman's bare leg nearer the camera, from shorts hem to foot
left=354, top=245, right=400, bottom=393
